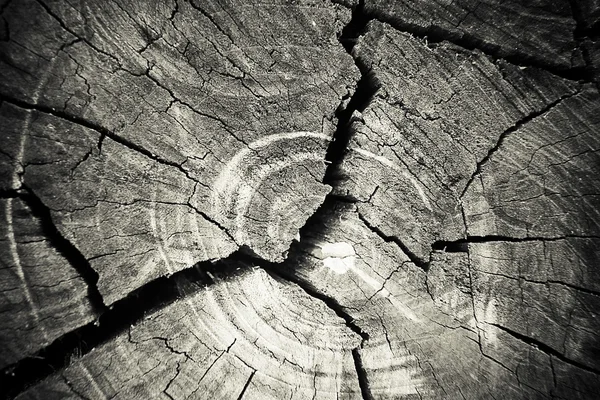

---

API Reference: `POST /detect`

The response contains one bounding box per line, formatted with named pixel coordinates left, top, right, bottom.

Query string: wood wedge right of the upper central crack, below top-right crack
left=338, top=22, right=584, bottom=263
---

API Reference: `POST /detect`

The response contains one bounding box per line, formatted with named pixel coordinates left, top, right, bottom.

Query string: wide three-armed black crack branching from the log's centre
left=0, top=1, right=379, bottom=400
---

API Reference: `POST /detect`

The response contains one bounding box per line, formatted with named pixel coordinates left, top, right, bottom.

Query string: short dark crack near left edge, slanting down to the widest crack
left=19, top=185, right=107, bottom=315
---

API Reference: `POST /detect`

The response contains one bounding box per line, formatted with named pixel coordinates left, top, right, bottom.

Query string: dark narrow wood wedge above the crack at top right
left=365, top=0, right=584, bottom=69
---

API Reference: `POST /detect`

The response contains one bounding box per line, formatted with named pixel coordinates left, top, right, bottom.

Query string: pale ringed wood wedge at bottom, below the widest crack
left=18, top=264, right=360, bottom=399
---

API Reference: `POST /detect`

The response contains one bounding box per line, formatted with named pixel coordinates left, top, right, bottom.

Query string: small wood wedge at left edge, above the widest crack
left=0, top=198, right=94, bottom=368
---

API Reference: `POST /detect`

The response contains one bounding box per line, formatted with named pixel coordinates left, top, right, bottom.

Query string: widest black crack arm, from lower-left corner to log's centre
left=0, top=251, right=249, bottom=399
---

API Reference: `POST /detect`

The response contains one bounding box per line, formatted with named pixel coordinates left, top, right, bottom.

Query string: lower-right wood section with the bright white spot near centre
left=286, top=204, right=600, bottom=399
